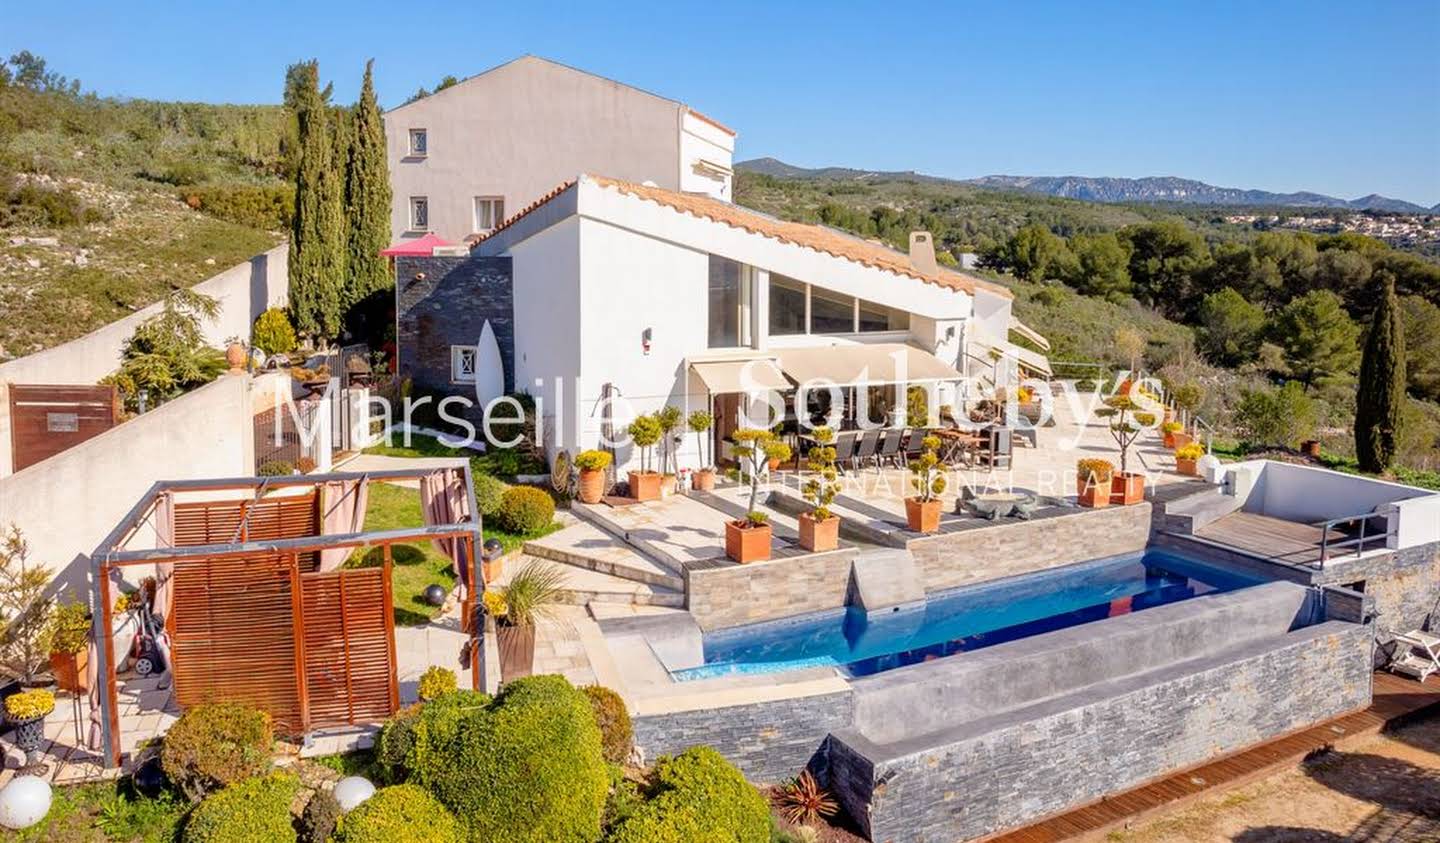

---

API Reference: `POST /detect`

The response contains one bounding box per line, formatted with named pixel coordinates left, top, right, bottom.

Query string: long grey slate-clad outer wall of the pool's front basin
left=825, top=624, right=1371, bottom=843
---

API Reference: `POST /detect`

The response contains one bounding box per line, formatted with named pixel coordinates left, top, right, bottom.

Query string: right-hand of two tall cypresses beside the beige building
left=344, top=59, right=393, bottom=310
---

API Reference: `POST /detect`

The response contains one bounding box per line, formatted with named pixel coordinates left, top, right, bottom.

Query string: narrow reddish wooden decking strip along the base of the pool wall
left=986, top=673, right=1440, bottom=843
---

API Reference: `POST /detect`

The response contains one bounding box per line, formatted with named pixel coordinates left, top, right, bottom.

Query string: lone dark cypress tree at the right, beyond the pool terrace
left=1355, top=269, right=1405, bottom=473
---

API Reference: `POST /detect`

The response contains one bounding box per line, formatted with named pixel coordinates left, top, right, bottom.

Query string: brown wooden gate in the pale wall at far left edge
left=10, top=383, right=120, bottom=471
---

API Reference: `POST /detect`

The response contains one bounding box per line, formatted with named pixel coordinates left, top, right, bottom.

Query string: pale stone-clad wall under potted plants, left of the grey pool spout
left=685, top=549, right=855, bottom=631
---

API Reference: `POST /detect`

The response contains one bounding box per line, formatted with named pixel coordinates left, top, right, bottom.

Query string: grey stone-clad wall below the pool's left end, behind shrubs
left=635, top=690, right=854, bottom=782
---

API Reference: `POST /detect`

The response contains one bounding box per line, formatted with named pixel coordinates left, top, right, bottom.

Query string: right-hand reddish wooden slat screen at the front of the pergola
left=301, top=568, right=396, bottom=729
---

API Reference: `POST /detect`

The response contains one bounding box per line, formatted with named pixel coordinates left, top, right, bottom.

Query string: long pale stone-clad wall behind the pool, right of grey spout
left=909, top=503, right=1151, bottom=591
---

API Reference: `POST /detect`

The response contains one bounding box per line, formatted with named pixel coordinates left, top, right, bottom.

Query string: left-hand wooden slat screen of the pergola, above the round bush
left=170, top=556, right=302, bottom=733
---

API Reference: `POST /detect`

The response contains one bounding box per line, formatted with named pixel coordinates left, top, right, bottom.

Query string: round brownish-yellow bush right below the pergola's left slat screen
left=160, top=703, right=275, bottom=798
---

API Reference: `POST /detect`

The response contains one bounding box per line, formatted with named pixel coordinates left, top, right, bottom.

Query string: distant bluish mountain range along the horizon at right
left=736, top=159, right=1440, bottom=213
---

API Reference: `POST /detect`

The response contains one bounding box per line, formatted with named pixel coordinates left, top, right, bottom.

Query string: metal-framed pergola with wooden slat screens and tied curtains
left=91, top=464, right=484, bottom=767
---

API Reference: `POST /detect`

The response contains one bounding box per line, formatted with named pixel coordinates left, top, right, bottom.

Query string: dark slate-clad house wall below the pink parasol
left=396, top=247, right=516, bottom=422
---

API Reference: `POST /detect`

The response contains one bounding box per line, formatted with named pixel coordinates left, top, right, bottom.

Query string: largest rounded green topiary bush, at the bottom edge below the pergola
left=409, top=676, right=609, bottom=843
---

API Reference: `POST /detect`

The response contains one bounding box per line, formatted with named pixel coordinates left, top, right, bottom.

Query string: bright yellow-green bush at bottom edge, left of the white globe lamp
left=180, top=772, right=300, bottom=843
